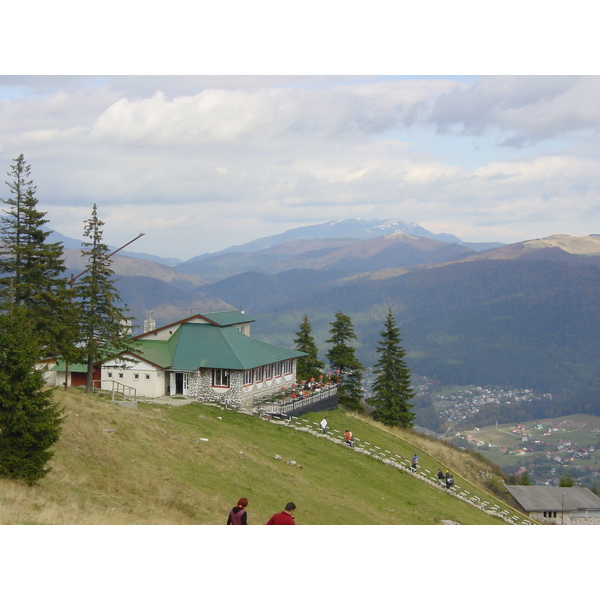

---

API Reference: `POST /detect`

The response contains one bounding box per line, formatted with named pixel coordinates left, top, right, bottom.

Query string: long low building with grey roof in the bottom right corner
left=506, top=485, right=600, bottom=525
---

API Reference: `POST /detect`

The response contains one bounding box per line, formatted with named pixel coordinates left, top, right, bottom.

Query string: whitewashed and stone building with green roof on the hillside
left=99, top=310, right=304, bottom=408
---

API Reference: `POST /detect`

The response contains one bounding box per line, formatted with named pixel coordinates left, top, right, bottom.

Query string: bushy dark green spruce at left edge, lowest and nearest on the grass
left=0, top=305, right=64, bottom=484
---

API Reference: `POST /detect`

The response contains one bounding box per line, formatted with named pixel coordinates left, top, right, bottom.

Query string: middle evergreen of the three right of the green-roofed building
left=325, top=311, right=364, bottom=410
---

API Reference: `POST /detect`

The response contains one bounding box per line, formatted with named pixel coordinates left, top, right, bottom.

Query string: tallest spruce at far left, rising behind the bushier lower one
left=0, top=154, right=78, bottom=355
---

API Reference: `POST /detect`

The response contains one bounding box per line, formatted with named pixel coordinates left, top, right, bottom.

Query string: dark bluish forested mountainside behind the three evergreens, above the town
left=216, top=255, right=600, bottom=412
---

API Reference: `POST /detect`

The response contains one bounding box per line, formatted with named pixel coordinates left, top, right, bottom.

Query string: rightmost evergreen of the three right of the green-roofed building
left=371, top=310, right=415, bottom=427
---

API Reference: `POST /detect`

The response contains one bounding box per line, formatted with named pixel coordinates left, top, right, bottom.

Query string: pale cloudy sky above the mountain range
left=0, top=2, right=600, bottom=260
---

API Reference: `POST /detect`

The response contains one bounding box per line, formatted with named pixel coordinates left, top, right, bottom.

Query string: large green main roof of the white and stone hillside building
left=136, top=322, right=304, bottom=371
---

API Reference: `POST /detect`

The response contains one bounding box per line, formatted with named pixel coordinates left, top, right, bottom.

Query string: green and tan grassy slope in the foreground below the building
left=0, top=390, right=536, bottom=525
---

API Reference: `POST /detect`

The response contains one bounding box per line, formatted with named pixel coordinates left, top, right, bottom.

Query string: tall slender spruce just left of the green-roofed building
left=75, top=204, right=135, bottom=392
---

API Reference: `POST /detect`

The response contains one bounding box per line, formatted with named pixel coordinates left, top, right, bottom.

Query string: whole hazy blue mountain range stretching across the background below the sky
left=56, top=220, right=600, bottom=420
